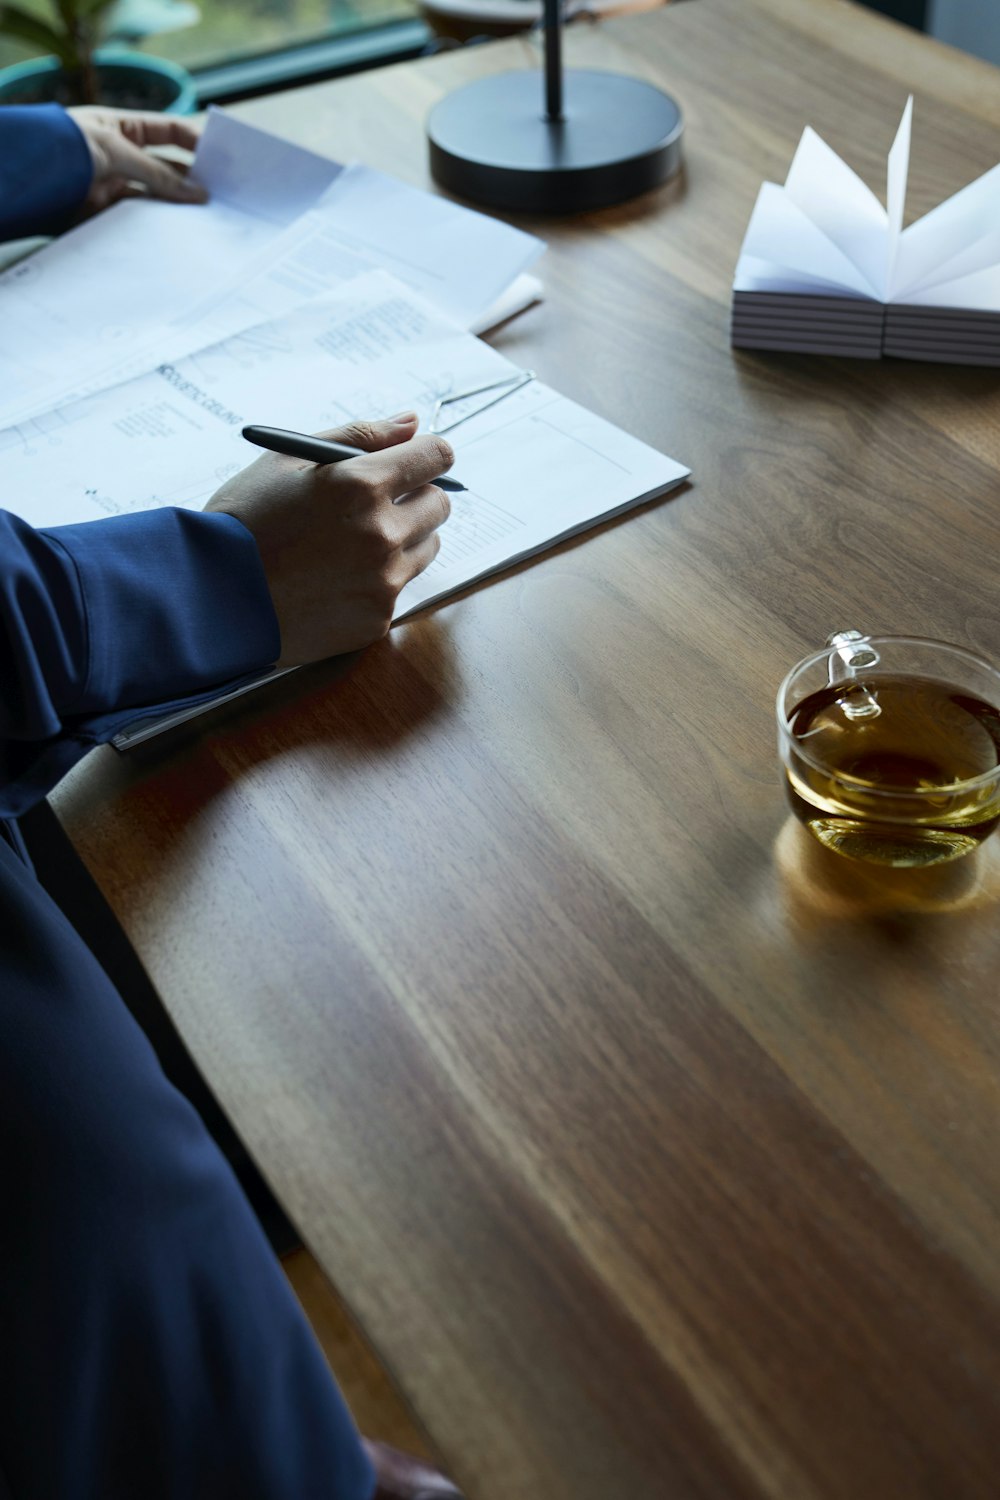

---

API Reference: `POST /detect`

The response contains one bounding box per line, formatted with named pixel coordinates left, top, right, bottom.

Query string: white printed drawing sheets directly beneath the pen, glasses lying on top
left=0, top=272, right=688, bottom=749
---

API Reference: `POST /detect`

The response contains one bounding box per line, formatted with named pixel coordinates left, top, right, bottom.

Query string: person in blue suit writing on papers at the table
left=0, top=107, right=459, bottom=1500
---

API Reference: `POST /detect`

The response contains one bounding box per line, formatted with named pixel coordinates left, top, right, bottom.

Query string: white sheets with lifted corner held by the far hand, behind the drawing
left=0, top=110, right=544, bottom=428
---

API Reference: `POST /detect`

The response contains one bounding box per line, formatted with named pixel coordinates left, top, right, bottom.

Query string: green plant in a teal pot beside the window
left=0, top=0, right=198, bottom=114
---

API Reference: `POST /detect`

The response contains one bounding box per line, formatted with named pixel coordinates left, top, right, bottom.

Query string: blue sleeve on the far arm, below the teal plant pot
left=0, top=104, right=93, bottom=240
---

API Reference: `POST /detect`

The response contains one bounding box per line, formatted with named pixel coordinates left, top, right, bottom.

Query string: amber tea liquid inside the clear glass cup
left=786, top=672, right=1000, bottom=866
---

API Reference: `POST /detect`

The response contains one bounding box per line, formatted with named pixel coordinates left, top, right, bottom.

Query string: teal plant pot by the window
left=0, top=48, right=198, bottom=114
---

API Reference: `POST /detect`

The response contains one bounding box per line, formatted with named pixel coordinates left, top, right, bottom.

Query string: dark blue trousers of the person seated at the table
left=0, top=837, right=375, bottom=1500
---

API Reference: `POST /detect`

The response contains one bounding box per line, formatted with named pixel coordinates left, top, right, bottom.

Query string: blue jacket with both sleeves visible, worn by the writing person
left=0, top=105, right=280, bottom=1044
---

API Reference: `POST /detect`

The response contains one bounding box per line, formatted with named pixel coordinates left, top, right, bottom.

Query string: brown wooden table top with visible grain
left=57, top=0, right=1000, bottom=1500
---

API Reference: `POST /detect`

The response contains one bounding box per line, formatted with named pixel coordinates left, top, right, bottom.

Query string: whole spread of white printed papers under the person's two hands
left=0, top=113, right=688, bottom=749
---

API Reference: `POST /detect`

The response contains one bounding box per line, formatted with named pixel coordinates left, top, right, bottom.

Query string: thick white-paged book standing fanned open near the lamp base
left=732, top=99, right=1000, bottom=365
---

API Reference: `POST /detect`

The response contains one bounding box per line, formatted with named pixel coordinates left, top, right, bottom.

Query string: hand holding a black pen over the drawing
left=205, top=413, right=454, bottom=666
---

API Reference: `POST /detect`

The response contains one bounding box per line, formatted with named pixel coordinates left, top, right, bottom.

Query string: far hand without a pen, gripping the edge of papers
left=67, top=105, right=208, bottom=215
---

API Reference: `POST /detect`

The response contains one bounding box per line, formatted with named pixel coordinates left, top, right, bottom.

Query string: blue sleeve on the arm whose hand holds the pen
left=0, top=509, right=280, bottom=818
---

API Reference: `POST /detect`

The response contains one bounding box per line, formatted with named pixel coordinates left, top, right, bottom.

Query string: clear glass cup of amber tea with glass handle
left=778, top=630, right=1000, bottom=867
